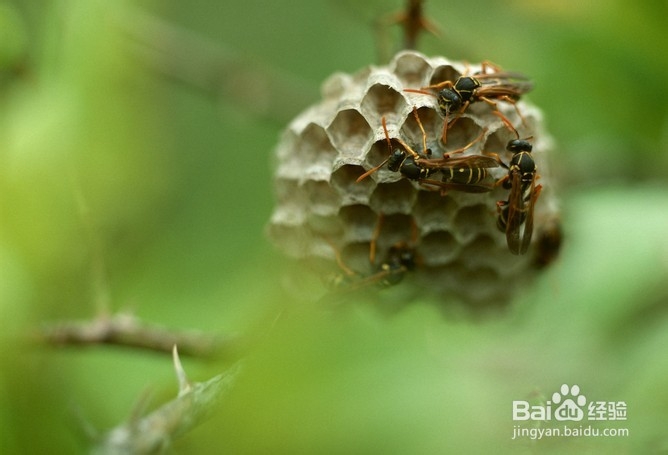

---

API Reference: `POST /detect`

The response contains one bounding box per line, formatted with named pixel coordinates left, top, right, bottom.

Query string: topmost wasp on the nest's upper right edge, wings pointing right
left=404, top=62, right=533, bottom=144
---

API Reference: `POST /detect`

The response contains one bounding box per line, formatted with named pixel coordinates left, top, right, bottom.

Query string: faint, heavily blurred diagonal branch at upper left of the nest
left=119, top=9, right=318, bottom=123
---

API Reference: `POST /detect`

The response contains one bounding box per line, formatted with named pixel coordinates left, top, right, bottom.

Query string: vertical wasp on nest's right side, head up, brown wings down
left=496, top=116, right=542, bottom=254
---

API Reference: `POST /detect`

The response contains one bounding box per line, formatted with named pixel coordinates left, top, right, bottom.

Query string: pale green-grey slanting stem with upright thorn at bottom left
left=91, top=346, right=241, bottom=454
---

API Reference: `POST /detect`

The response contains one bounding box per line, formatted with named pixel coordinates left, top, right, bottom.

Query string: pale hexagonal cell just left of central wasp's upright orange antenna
left=327, top=109, right=373, bottom=158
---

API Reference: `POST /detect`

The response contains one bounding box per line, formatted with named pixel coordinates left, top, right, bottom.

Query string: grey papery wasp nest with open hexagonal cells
left=269, top=51, right=558, bottom=314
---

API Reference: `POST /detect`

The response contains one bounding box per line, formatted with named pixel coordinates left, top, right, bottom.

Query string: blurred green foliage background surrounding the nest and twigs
left=0, top=0, right=668, bottom=454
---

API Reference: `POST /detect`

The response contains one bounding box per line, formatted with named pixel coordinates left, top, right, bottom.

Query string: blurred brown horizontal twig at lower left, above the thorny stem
left=38, top=314, right=236, bottom=358
